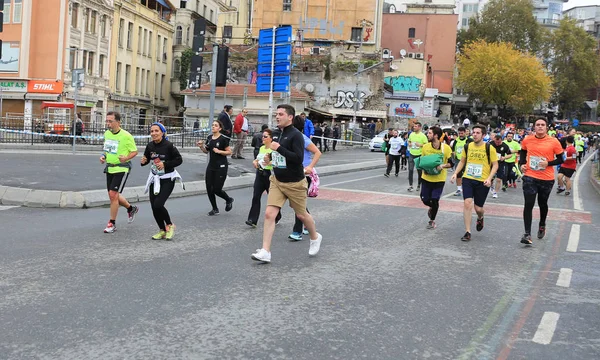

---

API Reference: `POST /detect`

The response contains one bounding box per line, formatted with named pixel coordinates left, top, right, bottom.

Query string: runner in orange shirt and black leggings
left=519, top=118, right=563, bottom=245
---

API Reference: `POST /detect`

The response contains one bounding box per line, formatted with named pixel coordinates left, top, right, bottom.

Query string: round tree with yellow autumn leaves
left=457, top=40, right=552, bottom=115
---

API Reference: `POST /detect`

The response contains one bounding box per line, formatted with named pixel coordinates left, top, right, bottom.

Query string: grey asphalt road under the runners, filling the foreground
left=0, top=160, right=600, bottom=359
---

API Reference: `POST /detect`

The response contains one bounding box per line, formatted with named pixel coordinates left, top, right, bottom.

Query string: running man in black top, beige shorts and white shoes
left=252, top=104, right=323, bottom=263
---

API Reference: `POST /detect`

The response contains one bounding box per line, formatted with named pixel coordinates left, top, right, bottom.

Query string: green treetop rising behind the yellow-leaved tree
left=457, top=0, right=545, bottom=53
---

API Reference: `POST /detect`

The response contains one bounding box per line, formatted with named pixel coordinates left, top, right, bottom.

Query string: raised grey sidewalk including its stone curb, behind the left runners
left=0, top=146, right=385, bottom=208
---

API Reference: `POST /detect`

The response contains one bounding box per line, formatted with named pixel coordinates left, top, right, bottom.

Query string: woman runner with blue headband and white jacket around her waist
left=140, top=123, right=183, bottom=240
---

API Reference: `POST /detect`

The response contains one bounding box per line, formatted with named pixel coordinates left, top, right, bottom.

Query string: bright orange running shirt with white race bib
left=521, top=135, right=564, bottom=180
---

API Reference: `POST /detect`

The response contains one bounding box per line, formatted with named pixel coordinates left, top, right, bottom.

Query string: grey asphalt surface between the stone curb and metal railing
left=0, top=148, right=383, bottom=191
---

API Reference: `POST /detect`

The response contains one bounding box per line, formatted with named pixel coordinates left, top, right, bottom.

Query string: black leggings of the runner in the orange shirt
left=523, top=176, right=554, bottom=234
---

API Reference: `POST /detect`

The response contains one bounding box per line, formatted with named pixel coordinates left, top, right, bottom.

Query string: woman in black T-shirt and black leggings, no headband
left=198, top=120, right=233, bottom=216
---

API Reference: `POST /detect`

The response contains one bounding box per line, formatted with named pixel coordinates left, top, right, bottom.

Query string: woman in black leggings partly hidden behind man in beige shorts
left=246, top=129, right=281, bottom=228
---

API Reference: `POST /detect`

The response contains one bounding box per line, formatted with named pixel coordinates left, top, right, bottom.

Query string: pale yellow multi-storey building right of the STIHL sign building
left=108, top=0, right=177, bottom=124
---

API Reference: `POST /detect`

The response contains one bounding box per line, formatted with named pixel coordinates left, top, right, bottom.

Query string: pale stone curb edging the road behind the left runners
left=0, top=161, right=382, bottom=209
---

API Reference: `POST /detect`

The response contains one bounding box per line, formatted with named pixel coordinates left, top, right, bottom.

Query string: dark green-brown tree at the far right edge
left=549, top=18, right=600, bottom=117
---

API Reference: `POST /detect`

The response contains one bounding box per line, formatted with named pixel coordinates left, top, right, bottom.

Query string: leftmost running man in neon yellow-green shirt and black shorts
left=100, top=111, right=139, bottom=234
